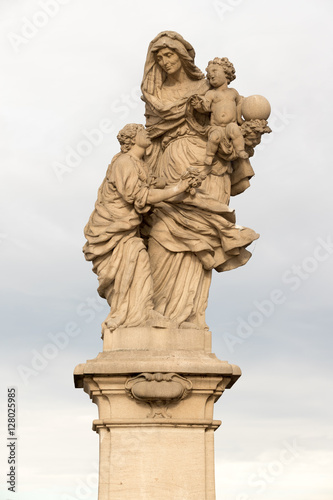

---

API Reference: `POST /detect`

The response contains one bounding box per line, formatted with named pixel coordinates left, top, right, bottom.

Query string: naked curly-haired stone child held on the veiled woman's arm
left=190, top=57, right=249, bottom=166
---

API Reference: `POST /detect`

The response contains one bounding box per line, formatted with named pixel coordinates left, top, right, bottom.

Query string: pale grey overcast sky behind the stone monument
left=0, top=0, right=333, bottom=500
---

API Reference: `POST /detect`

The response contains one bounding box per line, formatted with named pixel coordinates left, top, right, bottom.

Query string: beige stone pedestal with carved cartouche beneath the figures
left=74, top=327, right=241, bottom=500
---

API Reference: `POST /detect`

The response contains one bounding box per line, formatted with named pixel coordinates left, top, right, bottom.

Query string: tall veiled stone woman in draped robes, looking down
left=142, top=31, right=258, bottom=328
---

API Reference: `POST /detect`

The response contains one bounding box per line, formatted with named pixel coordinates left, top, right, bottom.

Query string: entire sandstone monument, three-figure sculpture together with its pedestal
left=74, top=31, right=270, bottom=500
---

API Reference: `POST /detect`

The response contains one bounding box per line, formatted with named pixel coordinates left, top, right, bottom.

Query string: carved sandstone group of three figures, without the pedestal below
left=84, top=31, right=270, bottom=331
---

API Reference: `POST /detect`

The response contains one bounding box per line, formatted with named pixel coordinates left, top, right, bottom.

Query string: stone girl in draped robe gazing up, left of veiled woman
left=83, top=124, right=198, bottom=330
